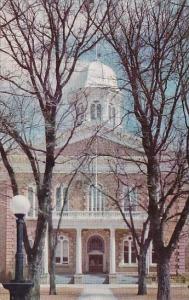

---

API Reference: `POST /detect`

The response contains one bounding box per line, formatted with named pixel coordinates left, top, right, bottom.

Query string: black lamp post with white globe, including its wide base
left=3, top=195, right=33, bottom=300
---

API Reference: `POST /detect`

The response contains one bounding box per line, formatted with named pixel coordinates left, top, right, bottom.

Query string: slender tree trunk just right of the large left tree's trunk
left=48, top=213, right=56, bottom=295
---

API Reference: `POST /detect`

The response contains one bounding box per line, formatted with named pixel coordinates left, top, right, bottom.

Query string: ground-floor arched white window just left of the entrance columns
left=55, top=236, right=69, bottom=265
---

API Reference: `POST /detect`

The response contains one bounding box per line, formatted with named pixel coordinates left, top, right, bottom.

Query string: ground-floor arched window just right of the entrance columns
left=123, top=237, right=137, bottom=264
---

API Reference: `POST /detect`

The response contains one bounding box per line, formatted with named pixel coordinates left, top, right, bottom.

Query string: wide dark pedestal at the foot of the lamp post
left=3, top=281, right=33, bottom=300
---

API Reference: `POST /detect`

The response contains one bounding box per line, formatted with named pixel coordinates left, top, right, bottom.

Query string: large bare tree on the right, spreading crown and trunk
left=102, top=0, right=189, bottom=300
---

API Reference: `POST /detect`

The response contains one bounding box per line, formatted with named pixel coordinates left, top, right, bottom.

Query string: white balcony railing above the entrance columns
left=54, top=211, right=146, bottom=219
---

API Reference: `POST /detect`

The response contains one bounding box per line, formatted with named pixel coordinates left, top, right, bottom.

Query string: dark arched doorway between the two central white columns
left=87, top=235, right=104, bottom=273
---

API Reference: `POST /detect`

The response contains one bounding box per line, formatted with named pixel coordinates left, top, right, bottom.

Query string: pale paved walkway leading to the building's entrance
left=78, top=285, right=117, bottom=300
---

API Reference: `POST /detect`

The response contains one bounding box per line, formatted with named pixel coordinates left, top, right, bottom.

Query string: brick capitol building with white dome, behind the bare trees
left=0, top=60, right=189, bottom=283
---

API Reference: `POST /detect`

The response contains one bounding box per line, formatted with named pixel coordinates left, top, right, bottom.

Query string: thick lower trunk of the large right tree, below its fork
left=157, top=255, right=171, bottom=300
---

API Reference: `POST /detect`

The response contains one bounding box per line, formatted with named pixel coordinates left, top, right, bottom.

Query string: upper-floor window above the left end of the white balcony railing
left=55, top=184, right=68, bottom=212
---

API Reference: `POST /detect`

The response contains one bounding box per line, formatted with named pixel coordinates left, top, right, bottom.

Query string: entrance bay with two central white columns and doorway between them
left=74, top=228, right=116, bottom=283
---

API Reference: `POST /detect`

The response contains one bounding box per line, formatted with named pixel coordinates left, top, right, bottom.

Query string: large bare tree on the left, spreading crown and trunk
left=0, top=0, right=105, bottom=300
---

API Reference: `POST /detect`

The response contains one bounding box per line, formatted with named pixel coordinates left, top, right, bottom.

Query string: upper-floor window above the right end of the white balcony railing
left=123, top=187, right=137, bottom=211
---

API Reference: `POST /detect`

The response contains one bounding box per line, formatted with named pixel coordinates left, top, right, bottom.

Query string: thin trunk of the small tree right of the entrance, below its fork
left=138, top=249, right=147, bottom=295
